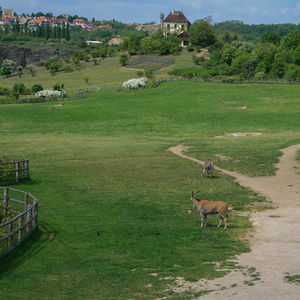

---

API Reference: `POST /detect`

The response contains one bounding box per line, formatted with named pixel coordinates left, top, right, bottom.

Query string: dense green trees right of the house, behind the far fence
left=171, top=25, right=300, bottom=79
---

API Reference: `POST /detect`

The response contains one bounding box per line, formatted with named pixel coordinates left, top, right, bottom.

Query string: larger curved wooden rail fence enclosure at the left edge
left=0, top=187, right=39, bottom=257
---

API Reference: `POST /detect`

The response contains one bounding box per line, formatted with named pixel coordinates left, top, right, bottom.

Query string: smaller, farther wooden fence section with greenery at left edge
left=0, top=156, right=29, bottom=182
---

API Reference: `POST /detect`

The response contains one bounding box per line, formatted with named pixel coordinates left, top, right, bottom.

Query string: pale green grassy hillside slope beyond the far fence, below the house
left=0, top=51, right=193, bottom=94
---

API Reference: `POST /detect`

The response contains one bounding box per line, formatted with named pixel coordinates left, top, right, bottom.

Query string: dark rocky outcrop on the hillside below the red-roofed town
left=0, top=44, right=74, bottom=67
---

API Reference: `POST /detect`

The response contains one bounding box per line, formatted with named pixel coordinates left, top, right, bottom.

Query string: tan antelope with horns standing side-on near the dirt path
left=190, top=191, right=228, bottom=229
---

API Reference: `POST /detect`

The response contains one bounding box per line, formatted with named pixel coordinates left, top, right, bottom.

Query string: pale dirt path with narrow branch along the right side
left=169, top=144, right=300, bottom=300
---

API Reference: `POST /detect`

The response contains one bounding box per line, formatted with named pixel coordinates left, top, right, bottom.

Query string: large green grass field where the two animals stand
left=0, top=78, right=300, bottom=299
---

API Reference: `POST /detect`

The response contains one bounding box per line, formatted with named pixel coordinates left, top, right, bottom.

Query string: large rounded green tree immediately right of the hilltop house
left=189, top=19, right=217, bottom=47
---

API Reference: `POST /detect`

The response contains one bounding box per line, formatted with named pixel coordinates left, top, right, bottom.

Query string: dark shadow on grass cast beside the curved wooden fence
left=0, top=222, right=57, bottom=279
